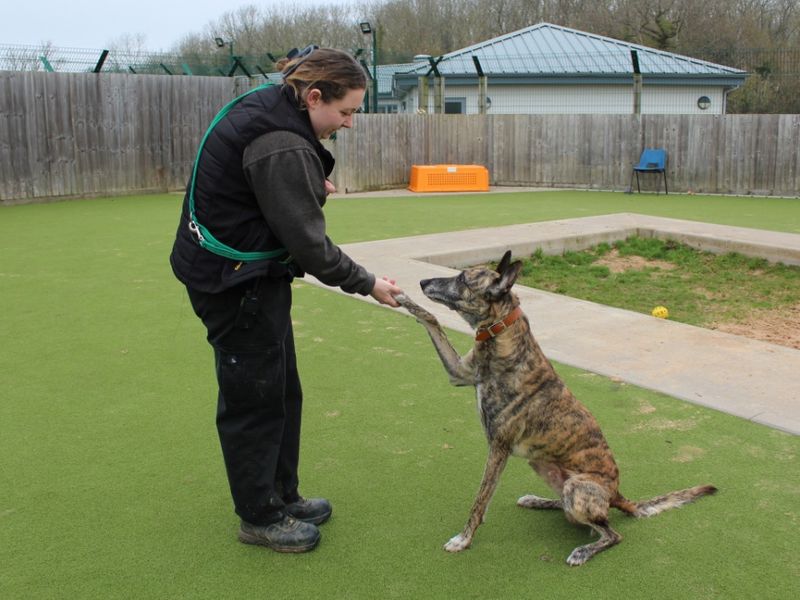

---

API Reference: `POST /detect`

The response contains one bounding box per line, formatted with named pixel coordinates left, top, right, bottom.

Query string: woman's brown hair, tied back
left=275, top=48, right=367, bottom=107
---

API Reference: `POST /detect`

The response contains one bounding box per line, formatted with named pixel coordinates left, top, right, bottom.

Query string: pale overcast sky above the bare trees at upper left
left=0, top=0, right=334, bottom=51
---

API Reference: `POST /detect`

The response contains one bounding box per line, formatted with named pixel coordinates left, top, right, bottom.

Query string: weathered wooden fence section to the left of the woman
left=0, top=71, right=247, bottom=203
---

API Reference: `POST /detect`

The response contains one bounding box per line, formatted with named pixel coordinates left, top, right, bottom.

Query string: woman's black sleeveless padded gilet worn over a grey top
left=170, top=85, right=334, bottom=293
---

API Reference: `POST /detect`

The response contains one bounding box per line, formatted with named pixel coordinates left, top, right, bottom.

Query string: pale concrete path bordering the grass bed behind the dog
left=308, top=213, right=800, bottom=434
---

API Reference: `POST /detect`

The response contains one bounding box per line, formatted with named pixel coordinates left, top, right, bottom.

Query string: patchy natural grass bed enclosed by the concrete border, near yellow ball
left=518, top=237, right=800, bottom=326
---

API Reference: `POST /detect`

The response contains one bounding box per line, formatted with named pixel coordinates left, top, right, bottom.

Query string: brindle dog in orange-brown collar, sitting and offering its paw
left=397, top=252, right=716, bottom=565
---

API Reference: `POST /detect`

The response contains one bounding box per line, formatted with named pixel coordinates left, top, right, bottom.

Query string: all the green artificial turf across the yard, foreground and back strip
left=0, top=192, right=800, bottom=599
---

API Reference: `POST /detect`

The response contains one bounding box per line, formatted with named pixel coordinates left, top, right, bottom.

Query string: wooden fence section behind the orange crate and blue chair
left=334, top=115, right=800, bottom=197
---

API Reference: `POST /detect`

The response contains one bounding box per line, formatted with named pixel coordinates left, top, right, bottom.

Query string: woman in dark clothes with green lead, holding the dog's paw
left=170, top=46, right=401, bottom=552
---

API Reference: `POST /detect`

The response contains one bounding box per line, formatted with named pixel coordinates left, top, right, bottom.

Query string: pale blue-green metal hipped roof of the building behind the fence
left=390, top=23, right=746, bottom=86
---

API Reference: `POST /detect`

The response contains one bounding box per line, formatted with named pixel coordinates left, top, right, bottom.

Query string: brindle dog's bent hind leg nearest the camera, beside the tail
left=562, top=475, right=622, bottom=566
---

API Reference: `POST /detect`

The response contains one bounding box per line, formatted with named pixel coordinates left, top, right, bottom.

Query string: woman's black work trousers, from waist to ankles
left=188, top=277, right=303, bottom=525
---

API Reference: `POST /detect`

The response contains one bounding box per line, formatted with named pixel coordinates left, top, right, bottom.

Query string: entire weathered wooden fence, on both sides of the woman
left=0, top=72, right=800, bottom=204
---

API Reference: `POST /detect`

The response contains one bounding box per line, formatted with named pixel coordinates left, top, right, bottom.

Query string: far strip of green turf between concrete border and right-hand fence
left=326, top=190, right=800, bottom=243
